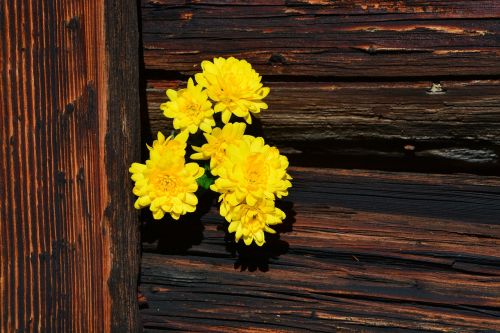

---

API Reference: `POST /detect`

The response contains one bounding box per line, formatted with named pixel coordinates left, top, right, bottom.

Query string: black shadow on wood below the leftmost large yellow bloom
left=141, top=191, right=215, bottom=254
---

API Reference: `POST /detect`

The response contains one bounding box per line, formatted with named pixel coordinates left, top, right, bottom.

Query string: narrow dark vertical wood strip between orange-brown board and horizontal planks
left=105, top=0, right=141, bottom=333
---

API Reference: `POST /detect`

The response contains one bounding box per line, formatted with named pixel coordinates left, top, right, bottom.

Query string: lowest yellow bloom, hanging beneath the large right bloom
left=220, top=200, right=285, bottom=246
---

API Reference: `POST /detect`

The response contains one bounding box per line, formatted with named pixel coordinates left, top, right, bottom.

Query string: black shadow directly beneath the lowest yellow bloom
left=221, top=201, right=296, bottom=272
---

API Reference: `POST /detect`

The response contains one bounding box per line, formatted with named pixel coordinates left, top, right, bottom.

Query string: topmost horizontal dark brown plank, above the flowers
left=142, top=0, right=500, bottom=77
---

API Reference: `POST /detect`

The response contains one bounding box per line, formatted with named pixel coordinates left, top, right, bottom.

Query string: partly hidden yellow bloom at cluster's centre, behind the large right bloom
left=191, top=123, right=246, bottom=175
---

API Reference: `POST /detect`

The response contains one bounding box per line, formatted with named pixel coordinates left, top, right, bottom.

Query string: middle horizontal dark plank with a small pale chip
left=147, top=79, right=500, bottom=173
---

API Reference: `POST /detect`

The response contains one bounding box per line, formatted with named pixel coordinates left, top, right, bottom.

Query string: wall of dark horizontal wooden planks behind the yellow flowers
left=140, top=0, right=500, bottom=332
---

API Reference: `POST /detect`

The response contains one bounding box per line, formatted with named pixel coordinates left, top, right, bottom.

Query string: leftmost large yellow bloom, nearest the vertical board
left=129, top=141, right=204, bottom=220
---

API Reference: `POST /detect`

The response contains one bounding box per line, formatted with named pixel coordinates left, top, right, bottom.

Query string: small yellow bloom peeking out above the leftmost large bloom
left=146, top=131, right=189, bottom=163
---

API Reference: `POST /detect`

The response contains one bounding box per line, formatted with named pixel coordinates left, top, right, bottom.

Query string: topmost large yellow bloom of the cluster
left=195, top=57, right=269, bottom=124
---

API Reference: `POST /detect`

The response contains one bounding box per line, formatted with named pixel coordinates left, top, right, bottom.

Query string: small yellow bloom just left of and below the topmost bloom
left=160, top=79, right=215, bottom=134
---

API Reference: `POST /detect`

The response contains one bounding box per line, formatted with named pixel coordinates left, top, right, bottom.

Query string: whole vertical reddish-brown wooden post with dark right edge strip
left=0, top=0, right=140, bottom=333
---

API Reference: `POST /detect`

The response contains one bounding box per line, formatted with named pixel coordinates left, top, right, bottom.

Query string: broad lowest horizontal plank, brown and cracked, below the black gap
left=140, top=168, right=500, bottom=332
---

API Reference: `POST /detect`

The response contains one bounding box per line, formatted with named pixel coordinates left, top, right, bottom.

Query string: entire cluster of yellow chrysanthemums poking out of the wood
left=130, top=57, right=292, bottom=246
